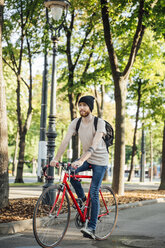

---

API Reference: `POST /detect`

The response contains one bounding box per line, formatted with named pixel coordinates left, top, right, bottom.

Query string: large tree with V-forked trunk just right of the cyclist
left=101, top=0, right=164, bottom=194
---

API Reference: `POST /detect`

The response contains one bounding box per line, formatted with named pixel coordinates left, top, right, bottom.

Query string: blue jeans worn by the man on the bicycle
left=70, top=161, right=107, bottom=230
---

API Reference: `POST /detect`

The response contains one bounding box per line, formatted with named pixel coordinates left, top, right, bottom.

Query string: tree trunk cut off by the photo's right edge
left=159, top=121, right=165, bottom=190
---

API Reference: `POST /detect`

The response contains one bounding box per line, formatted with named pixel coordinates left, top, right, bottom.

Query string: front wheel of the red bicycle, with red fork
left=33, top=185, right=70, bottom=248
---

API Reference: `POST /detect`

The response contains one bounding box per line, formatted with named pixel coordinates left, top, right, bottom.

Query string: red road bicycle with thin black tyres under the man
left=33, top=163, right=118, bottom=248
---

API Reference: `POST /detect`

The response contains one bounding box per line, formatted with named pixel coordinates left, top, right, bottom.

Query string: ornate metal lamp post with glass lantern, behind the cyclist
left=44, top=0, right=70, bottom=188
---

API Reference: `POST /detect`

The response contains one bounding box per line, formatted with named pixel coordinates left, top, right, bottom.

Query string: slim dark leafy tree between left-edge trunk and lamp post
left=4, top=0, right=45, bottom=183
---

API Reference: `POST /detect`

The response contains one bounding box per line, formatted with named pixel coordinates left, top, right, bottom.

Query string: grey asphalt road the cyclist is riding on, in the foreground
left=0, top=202, right=165, bottom=248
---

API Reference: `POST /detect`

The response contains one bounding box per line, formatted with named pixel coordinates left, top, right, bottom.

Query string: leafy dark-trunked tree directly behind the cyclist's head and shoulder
left=59, top=6, right=100, bottom=160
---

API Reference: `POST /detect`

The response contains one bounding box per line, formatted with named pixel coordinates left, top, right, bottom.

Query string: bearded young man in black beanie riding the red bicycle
left=50, top=96, right=108, bottom=239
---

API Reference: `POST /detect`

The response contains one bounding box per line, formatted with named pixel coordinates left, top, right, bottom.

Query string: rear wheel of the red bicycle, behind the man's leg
left=95, top=186, right=118, bottom=240
